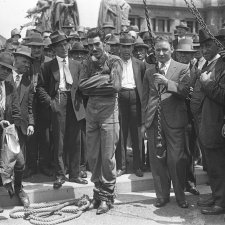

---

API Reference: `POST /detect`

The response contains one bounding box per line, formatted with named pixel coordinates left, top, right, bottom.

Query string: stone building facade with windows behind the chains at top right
left=127, top=0, right=225, bottom=36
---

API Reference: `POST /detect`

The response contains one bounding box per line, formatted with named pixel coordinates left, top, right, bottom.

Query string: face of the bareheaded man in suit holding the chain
left=155, top=41, right=173, bottom=63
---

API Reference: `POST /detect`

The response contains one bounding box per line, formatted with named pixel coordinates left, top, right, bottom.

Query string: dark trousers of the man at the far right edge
left=204, top=147, right=225, bottom=208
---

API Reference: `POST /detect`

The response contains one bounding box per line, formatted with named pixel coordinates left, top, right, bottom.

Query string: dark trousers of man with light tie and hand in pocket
left=52, top=92, right=81, bottom=178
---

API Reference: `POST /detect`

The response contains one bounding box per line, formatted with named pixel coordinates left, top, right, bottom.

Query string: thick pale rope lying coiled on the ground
left=9, top=195, right=90, bottom=225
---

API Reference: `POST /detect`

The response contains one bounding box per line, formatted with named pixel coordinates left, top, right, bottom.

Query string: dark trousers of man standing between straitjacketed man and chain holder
left=119, top=89, right=141, bottom=170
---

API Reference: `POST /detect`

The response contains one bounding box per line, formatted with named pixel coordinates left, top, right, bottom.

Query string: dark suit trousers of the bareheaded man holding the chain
left=147, top=114, right=186, bottom=202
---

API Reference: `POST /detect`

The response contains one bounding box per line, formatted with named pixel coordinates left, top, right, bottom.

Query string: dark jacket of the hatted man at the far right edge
left=199, top=58, right=225, bottom=149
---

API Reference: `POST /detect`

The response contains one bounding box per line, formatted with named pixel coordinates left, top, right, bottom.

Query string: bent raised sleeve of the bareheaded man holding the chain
left=167, top=63, right=191, bottom=98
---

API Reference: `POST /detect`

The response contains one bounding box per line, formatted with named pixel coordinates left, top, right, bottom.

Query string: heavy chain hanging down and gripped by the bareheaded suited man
left=143, top=0, right=166, bottom=159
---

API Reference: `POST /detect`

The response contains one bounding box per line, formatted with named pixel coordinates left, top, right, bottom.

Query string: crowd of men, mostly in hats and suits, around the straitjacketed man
left=0, top=21, right=225, bottom=215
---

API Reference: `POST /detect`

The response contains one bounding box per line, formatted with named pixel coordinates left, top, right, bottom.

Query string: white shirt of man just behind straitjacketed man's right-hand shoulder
left=122, top=59, right=136, bottom=89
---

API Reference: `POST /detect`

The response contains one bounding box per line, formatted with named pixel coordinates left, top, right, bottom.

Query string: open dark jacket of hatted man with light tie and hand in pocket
left=37, top=58, right=85, bottom=121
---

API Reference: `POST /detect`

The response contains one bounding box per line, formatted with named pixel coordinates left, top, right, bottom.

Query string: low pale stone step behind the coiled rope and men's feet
left=0, top=168, right=208, bottom=207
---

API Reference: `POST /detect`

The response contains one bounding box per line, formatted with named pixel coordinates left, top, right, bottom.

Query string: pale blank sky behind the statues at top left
left=0, top=0, right=101, bottom=38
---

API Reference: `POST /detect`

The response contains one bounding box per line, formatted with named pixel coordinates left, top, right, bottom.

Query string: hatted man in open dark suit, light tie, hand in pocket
left=37, top=31, right=87, bottom=189
